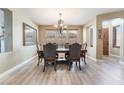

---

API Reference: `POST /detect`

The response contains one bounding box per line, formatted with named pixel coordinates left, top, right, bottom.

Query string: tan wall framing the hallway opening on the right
left=96, top=11, right=124, bottom=59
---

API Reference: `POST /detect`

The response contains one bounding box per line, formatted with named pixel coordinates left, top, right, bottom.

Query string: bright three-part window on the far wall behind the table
left=45, top=30, right=78, bottom=47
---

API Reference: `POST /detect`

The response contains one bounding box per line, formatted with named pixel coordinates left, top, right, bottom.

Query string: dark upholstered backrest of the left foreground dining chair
left=43, top=43, right=56, bottom=59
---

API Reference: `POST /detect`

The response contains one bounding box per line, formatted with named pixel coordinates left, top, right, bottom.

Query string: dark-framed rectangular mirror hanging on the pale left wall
left=23, top=23, right=37, bottom=46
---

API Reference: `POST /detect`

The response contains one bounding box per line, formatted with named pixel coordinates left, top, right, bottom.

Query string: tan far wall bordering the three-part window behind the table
left=39, top=25, right=83, bottom=45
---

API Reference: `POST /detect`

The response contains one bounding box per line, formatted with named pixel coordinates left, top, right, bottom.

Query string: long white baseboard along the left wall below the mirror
left=0, top=55, right=37, bottom=79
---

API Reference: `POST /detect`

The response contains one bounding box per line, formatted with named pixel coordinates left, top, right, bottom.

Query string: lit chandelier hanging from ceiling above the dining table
left=54, top=13, right=67, bottom=34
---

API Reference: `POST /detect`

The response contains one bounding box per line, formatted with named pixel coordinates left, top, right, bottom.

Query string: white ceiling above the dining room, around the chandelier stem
left=22, top=8, right=122, bottom=25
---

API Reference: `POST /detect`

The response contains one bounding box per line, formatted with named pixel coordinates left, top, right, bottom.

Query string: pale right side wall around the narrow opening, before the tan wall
left=83, top=18, right=96, bottom=59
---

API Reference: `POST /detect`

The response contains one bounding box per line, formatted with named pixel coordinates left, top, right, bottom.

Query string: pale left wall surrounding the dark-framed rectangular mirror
left=0, top=9, right=37, bottom=73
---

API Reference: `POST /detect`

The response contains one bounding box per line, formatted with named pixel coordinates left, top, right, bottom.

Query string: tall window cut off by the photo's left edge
left=0, top=8, right=12, bottom=53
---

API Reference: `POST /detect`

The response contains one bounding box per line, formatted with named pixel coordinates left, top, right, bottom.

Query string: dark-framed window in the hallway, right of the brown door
left=113, top=25, right=121, bottom=48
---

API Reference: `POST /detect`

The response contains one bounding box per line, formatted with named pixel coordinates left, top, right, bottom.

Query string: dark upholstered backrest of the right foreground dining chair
left=69, top=43, right=81, bottom=59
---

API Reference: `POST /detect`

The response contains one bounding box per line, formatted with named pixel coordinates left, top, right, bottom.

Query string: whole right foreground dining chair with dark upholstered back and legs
left=68, top=43, right=81, bottom=70
